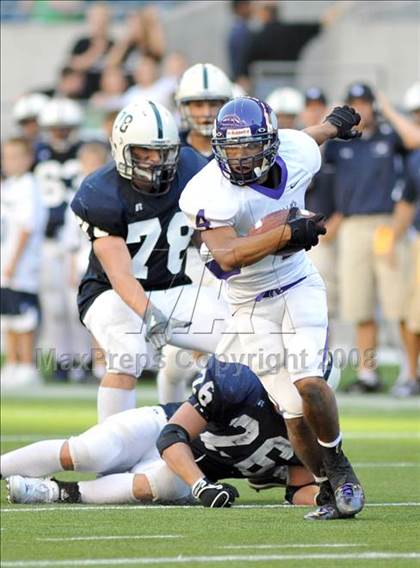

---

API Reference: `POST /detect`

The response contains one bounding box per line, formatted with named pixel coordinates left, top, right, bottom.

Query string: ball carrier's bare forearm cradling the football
left=202, top=225, right=292, bottom=271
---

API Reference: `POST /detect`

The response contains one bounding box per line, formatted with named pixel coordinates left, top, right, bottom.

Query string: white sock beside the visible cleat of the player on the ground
left=78, top=473, right=138, bottom=504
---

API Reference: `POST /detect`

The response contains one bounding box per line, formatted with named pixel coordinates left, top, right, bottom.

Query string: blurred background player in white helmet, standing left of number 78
left=33, top=98, right=83, bottom=380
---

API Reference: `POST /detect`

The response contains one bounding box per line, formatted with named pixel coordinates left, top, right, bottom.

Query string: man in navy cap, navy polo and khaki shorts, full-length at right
left=325, top=83, right=416, bottom=392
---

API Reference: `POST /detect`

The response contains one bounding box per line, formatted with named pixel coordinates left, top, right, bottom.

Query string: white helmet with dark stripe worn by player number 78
left=110, top=99, right=180, bottom=195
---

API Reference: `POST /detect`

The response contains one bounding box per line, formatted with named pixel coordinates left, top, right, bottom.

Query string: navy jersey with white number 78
left=71, top=148, right=206, bottom=320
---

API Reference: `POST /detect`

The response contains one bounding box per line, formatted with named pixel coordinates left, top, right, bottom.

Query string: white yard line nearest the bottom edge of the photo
left=2, top=552, right=420, bottom=568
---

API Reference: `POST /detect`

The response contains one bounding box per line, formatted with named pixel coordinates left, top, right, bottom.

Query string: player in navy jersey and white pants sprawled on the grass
left=1, top=357, right=334, bottom=507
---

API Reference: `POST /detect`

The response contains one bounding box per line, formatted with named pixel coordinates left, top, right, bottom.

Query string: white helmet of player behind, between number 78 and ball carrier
left=175, top=63, right=233, bottom=136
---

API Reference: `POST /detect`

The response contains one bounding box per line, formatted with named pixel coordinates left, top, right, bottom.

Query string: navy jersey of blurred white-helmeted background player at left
left=33, top=142, right=82, bottom=238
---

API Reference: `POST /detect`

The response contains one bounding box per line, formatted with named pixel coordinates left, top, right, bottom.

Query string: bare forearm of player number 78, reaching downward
left=93, top=237, right=149, bottom=317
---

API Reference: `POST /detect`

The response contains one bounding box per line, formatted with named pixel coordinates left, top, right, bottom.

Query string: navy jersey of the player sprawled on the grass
left=188, top=357, right=301, bottom=481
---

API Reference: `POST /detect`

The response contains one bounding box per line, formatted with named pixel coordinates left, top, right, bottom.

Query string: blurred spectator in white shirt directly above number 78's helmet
left=123, top=56, right=178, bottom=108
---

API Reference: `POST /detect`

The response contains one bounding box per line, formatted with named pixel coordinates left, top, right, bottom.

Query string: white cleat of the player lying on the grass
left=7, top=475, right=59, bottom=503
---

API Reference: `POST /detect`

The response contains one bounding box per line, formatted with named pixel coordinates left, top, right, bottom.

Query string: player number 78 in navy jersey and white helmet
left=71, top=100, right=228, bottom=421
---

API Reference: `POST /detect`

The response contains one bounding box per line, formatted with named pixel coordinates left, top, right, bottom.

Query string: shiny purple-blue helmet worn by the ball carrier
left=212, top=97, right=280, bottom=185
